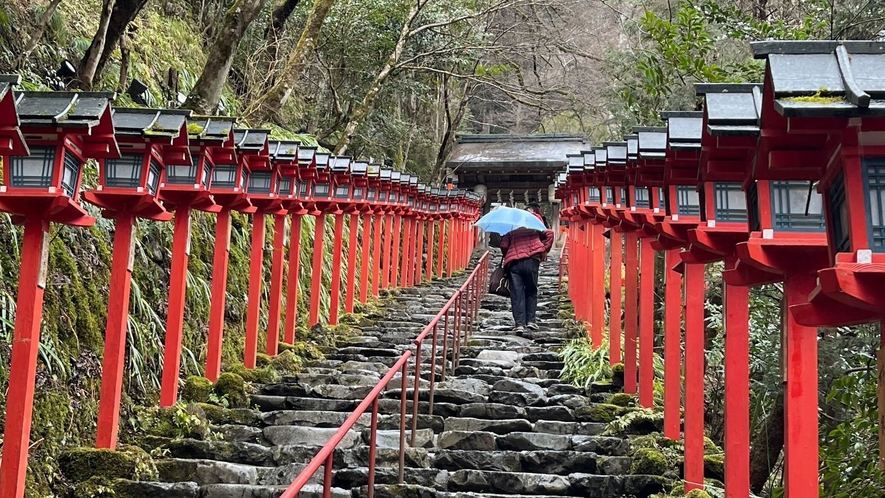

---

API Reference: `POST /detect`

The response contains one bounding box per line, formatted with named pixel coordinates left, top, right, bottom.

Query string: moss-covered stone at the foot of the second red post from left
left=58, top=446, right=157, bottom=483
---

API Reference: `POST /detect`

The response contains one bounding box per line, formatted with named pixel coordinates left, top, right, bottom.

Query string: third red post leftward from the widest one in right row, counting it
left=684, top=264, right=704, bottom=496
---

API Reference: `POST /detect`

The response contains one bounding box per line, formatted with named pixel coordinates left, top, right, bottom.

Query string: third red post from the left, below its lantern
left=160, top=205, right=191, bottom=407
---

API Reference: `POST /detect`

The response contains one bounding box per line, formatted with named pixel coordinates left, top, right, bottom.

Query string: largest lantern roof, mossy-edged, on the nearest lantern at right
left=751, top=41, right=885, bottom=117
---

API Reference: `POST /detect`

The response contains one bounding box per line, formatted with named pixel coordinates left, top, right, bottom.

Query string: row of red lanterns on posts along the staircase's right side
left=557, top=41, right=885, bottom=497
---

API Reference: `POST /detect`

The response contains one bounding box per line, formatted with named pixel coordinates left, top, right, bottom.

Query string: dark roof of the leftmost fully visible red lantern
left=16, top=92, right=115, bottom=128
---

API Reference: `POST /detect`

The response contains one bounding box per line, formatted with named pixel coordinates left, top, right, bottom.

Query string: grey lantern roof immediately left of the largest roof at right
left=695, top=83, right=762, bottom=136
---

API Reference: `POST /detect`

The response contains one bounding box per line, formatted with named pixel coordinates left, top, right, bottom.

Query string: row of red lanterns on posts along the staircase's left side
left=0, top=76, right=483, bottom=498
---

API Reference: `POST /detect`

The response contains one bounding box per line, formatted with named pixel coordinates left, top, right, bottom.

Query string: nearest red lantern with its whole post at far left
left=0, top=87, right=120, bottom=498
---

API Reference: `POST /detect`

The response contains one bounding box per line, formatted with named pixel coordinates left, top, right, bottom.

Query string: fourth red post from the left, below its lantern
left=206, top=207, right=231, bottom=382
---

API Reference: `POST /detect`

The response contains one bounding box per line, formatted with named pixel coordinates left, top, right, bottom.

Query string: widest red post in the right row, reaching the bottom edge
left=782, top=275, right=818, bottom=498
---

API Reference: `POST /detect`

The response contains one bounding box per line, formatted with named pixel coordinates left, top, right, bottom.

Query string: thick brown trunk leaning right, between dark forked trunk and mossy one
left=182, top=0, right=266, bottom=114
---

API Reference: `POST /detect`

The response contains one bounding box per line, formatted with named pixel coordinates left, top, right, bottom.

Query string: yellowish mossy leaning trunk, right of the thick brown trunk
left=244, top=0, right=335, bottom=123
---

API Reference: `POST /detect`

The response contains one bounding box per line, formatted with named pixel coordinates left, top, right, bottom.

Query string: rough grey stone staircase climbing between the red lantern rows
left=118, top=260, right=666, bottom=498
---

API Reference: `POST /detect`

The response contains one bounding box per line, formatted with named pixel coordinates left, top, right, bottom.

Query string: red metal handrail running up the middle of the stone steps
left=280, top=252, right=489, bottom=498
